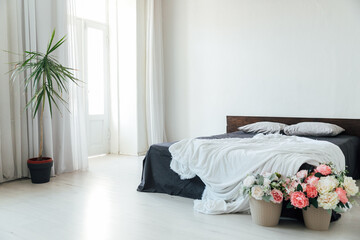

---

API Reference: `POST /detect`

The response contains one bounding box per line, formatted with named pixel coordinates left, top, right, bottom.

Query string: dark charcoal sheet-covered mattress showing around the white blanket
left=137, top=131, right=360, bottom=199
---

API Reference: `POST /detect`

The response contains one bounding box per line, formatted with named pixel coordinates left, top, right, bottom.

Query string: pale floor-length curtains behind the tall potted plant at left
left=0, top=0, right=88, bottom=184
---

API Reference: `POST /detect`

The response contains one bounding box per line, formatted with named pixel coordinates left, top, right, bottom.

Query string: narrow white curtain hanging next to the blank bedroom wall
left=146, top=0, right=166, bottom=145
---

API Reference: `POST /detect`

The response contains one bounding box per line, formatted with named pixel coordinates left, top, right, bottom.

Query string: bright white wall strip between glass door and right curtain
left=109, top=0, right=140, bottom=155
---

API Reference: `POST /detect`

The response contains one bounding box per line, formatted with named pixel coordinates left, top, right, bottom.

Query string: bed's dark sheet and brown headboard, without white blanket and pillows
left=137, top=116, right=360, bottom=220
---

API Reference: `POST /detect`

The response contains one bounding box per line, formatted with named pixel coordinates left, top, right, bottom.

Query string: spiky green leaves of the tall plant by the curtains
left=11, top=30, right=80, bottom=117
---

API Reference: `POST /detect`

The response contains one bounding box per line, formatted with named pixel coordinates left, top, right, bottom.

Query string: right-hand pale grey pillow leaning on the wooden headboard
left=284, top=122, right=345, bottom=137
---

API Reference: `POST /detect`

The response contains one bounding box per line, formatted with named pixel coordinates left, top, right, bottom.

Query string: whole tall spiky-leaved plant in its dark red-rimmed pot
left=11, top=30, right=79, bottom=183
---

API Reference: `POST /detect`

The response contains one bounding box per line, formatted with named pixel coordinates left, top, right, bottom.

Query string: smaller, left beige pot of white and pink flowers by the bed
left=242, top=173, right=283, bottom=227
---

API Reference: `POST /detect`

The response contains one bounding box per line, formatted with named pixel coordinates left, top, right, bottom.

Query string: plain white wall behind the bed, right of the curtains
left=163, top=0, right=360, bottom=140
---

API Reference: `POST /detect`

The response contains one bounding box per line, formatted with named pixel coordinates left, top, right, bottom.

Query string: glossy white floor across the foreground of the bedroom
left=0, top=155, right=360, bottom=240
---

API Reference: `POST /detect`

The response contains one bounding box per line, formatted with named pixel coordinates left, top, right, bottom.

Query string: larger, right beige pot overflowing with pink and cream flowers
left=283, top=163, right=359, bottom=230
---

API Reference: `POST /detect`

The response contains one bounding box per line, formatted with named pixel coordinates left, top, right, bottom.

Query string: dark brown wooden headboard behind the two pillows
left=226, top=116, right=360, bottom=137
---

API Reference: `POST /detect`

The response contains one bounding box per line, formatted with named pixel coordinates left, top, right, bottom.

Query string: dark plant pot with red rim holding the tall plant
left=27, top=157, right=54, bottom=183
